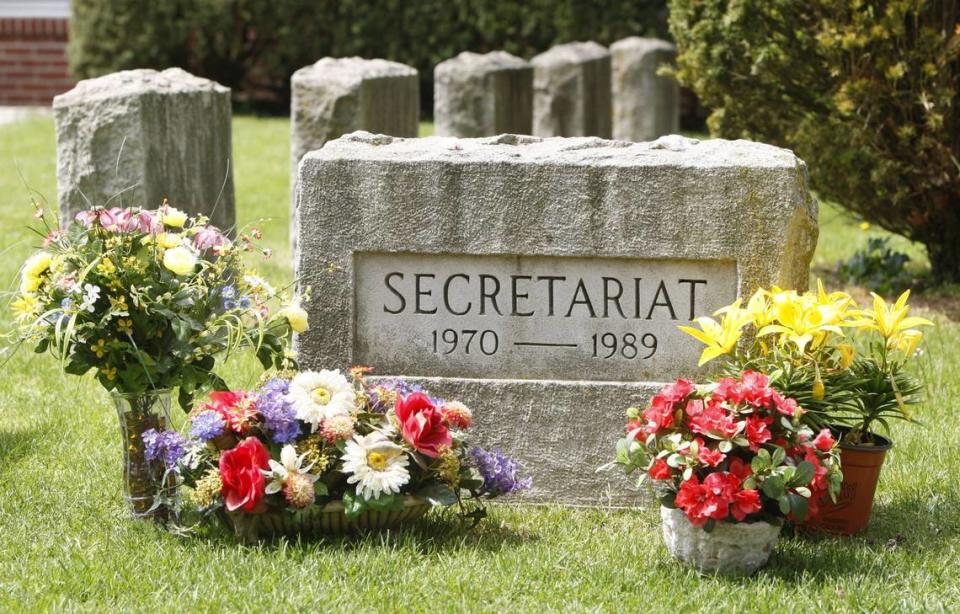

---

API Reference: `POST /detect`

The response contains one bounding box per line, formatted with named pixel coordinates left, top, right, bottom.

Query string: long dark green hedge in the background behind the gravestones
left=70, top=0, right=667, bottom=110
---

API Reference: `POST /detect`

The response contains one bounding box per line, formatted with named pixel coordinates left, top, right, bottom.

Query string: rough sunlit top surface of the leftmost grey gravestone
left=53, top=68, right=230, bottom=108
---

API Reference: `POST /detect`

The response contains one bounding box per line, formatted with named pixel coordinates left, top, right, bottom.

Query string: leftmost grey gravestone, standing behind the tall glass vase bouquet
left=53, top=68, right=235, bottom=229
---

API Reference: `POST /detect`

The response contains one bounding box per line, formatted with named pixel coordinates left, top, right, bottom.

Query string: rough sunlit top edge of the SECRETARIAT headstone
left=303, top=131, right=802, bottom=168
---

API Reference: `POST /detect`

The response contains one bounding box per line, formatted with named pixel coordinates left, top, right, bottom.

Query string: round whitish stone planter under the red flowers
left=660, top=507, right=782, bottom=574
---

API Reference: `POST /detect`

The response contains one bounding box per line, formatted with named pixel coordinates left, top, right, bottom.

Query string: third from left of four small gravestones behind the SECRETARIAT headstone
left=530, top=42, right=611, bottom=138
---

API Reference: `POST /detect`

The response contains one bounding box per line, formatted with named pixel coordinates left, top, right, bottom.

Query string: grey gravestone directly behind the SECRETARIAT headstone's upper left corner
left=290, top=58, right=420, bottom=252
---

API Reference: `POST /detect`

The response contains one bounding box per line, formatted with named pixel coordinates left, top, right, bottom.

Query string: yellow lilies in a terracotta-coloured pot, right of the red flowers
left=681, top=282, right=932, bottom=534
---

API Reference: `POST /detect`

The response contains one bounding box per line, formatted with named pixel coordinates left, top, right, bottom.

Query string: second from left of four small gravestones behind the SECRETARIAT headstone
left=433, top=51, right=533, bottom=137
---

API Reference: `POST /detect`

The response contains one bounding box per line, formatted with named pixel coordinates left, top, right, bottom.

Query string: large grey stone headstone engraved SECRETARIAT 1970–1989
left=297, top=132, right=817, bottom=505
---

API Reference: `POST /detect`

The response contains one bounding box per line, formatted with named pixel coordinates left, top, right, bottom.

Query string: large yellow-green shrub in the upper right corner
left=670, top=0, right=960, bottom=281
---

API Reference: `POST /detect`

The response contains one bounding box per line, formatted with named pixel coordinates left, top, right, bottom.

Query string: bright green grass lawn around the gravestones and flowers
left=0, top=117, right=960, bottom=612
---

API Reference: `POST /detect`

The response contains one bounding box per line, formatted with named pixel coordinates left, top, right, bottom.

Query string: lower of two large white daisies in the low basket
left=343, top=431, right=410, bottom=501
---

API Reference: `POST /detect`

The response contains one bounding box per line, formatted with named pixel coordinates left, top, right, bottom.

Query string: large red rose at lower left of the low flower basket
left=220, top=437, right=270, bottom=514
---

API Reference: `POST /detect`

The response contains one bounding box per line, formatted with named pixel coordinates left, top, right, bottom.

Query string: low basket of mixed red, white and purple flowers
left=158, top=368, right=530, bottom=542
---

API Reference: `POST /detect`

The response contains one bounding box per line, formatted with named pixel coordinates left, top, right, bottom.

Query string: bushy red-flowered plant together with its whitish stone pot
left=612, top=371, right=842, bottom=573
